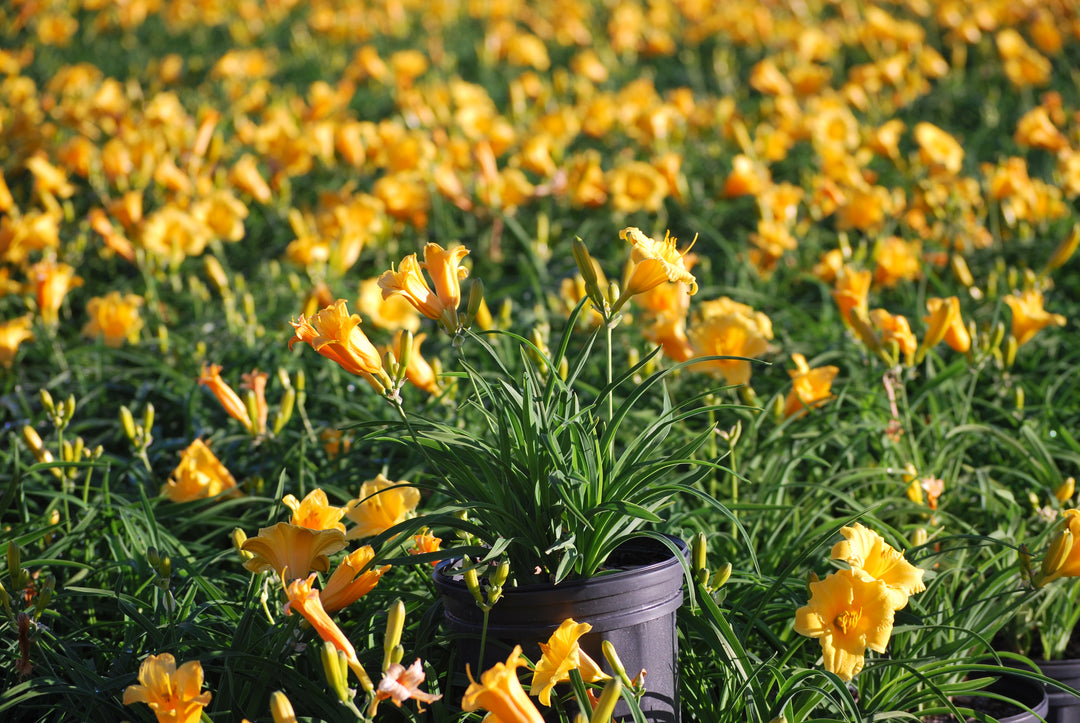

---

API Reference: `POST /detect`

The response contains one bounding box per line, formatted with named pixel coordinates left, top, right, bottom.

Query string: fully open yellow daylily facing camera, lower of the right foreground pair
left=795, top=570, right=894, bottom=681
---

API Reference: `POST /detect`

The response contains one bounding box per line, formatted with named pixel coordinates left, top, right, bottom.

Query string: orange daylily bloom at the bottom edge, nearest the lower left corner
left=124, top=653, right=211, bottom=723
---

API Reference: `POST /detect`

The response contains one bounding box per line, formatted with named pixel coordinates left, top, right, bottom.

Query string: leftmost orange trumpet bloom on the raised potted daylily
left=288, top=299, right=390, bottom=393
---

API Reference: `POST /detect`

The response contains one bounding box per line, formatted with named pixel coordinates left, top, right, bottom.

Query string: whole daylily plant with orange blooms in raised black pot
left=294, top=228, right=733, bottom=721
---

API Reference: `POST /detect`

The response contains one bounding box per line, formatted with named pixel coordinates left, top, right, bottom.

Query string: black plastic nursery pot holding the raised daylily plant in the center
left=434, top=537, right=688, bottom=723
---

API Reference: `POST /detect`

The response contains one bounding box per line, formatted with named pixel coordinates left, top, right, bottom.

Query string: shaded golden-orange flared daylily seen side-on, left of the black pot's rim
left=241, top=522, right=346, bottom=580
